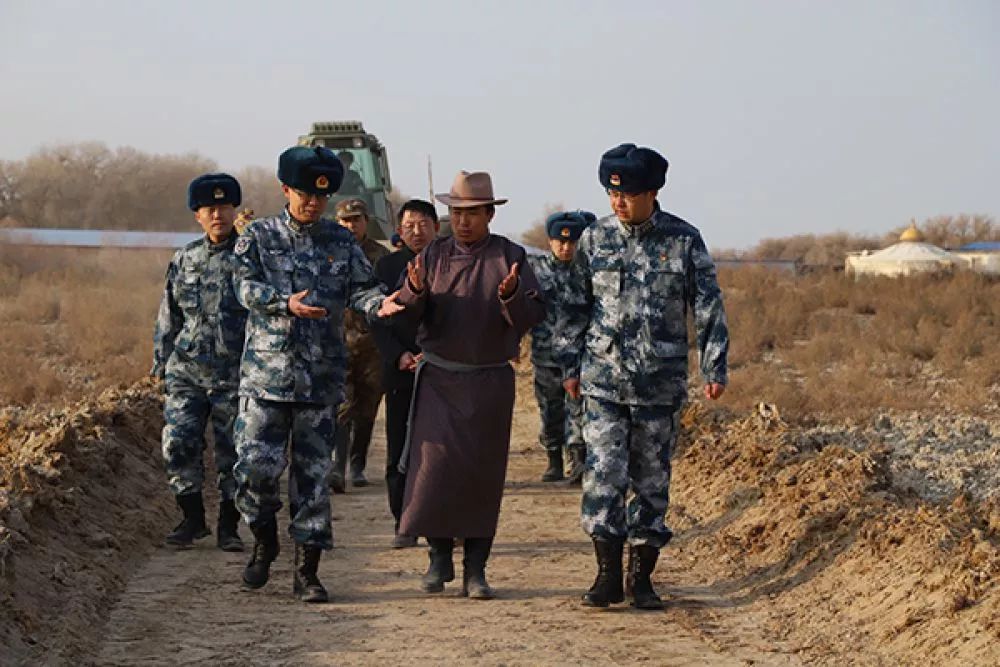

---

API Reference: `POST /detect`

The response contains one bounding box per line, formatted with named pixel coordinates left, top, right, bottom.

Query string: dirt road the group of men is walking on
left=95, top=411, right=798, bottom=665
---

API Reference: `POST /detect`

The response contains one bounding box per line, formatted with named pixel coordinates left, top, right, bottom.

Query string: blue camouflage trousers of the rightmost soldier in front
left=580, top=396, right=680, bottom=548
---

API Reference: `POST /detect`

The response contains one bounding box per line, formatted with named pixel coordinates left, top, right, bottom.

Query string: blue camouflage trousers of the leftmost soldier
left=161, top=384, right=239, bottom=500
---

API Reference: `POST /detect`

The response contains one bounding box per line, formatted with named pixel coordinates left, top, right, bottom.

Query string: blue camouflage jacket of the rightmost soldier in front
left=555, top=207, right=729, bottom=405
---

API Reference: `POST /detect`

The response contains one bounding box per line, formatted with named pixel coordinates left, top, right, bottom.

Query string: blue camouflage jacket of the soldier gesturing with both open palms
left=236, top=209, right=384, bottom=405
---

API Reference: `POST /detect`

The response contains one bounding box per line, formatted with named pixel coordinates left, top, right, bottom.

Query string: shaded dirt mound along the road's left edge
left=0, top=381, right=169, bottom=664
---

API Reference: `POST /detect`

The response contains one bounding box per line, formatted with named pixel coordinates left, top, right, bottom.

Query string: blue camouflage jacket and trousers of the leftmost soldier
left=151, top=234, right=247, bottom=499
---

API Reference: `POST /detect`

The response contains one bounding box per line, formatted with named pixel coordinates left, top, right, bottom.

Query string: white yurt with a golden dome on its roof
left=844, top=223, right=966, bottom=278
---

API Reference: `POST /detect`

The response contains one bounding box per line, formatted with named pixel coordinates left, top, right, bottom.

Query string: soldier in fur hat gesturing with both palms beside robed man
left=235, top=146, right=401, bottom=602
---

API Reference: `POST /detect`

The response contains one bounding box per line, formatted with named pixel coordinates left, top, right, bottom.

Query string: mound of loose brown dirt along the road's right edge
left=672, top=405, right=1000, bottom=664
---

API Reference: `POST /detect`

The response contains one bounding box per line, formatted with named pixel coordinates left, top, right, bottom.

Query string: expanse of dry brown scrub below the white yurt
left=720, top=268, right=1000, bottom=418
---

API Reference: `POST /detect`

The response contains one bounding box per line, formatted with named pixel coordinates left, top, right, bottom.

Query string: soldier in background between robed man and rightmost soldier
left=528, top=211, right=596, bottom=484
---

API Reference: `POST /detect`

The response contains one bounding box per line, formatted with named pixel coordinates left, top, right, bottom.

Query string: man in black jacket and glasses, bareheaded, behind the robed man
left=372, top=199, right=440, bottom=549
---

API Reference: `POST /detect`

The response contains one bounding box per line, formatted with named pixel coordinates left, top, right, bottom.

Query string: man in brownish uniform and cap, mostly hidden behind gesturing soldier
left=330, top=199, right=389, bottom=493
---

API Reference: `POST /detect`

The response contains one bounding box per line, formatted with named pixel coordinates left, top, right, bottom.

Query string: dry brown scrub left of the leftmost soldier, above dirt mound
left=0, top=247, right=169, bottom=405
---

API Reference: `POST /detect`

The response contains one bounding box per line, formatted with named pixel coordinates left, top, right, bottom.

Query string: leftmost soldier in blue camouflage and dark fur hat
left=151, top=174, right=247, bottom=551
